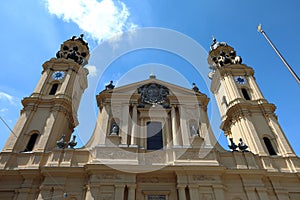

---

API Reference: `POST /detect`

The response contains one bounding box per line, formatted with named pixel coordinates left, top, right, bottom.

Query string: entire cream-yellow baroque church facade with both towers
left=0, top=37, right=300, bottom=200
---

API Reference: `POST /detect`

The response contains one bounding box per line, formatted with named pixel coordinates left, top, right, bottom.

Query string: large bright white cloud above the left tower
left=46, top=0, right=136, bottom=42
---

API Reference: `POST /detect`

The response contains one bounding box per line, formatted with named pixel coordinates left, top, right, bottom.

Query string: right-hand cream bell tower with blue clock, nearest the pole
left=208, top=39, right=295, bottom=156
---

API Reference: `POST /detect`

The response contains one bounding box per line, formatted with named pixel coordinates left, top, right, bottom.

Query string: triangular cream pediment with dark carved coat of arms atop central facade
left=97, top=78, right=209, bottom=106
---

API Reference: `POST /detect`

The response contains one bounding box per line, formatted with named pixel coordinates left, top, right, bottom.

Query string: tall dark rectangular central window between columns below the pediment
left=147, top=122, right=163, bottom=150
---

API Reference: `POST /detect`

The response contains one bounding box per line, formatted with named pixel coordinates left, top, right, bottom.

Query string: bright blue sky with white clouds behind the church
left=0, top=0, right=300, bottom=155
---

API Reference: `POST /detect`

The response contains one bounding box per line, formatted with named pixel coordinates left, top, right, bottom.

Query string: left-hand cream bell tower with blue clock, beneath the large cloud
left=3, top=35, right=89, bottom=152
